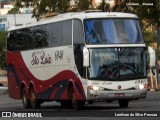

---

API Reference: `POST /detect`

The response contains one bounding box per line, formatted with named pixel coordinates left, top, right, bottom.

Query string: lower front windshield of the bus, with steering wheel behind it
left=89, top=48, right=146, bottom=80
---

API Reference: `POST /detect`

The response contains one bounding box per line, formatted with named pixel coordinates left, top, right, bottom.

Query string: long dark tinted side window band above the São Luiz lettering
left=7, top=20, right=72, bottom=50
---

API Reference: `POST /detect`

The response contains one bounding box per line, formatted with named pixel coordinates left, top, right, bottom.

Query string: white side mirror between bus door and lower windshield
left=83, top=47, right=89, bottom=67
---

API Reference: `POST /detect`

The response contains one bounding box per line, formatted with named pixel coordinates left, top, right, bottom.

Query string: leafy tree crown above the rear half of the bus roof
left=11, top=0, right=69, bottom=20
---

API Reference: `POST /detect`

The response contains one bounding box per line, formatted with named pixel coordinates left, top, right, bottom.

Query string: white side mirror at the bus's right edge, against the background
left=148, top=47, right=156, bottom=67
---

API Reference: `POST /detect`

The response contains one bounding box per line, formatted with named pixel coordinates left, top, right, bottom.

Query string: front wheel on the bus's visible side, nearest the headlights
left=69, top=87, right=85, bottom=110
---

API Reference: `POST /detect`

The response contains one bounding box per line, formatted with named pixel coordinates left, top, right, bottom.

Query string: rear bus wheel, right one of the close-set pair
left=30, top=87, right=41, bottom=109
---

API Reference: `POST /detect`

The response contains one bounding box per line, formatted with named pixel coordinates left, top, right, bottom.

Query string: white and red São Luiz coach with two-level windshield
left=7, top=11, right=148, bottom=109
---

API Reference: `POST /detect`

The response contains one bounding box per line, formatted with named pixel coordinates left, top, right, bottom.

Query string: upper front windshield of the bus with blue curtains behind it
left=84, top=19, right=144, bottom=44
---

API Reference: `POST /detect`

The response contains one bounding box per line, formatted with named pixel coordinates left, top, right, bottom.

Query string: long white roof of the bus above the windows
left=8, top=12, right=138, bottom=31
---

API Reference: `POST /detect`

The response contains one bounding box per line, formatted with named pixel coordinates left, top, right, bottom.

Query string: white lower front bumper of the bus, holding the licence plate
left=87, top=88, right=147, bottom=100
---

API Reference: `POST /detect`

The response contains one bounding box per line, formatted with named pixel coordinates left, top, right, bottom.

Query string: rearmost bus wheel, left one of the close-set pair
left=21, top=87, right=31, bottom=109
